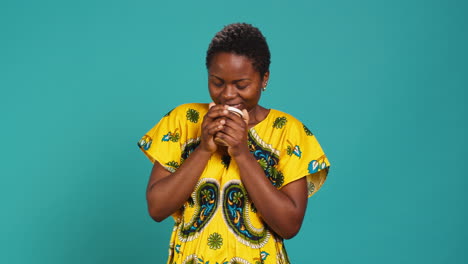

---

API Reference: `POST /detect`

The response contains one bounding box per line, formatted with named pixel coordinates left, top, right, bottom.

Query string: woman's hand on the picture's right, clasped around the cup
left=214, top=106, right=250, bottom=157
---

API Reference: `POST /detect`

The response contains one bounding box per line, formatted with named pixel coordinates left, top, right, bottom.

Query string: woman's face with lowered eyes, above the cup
left=208, top=52, right=269, bottom=112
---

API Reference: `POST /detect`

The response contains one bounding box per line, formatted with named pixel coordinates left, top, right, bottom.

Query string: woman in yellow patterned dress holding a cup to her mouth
left=139, top=24, right=329, bottom=264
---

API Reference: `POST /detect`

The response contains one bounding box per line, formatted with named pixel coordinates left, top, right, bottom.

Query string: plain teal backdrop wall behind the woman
left=0, top=0, right=468, bottom=264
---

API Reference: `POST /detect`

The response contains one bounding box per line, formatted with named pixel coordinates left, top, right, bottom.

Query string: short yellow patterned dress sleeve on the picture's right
left=278, top=120, right=330, bottom=197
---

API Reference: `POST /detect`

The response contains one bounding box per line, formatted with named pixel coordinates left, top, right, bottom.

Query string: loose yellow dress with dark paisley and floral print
left=138, top=103, right=329, bottom=264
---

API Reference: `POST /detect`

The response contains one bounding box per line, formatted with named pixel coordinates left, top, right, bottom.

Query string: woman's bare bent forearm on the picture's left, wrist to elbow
left=146, top=148, right=211, bottom=222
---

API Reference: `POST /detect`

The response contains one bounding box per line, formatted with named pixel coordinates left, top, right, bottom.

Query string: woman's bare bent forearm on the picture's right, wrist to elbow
left=236, top=153, right=307, bottom=238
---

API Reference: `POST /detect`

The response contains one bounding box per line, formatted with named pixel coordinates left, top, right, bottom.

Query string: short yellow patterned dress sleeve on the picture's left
left=138, top=107, right=183, bottom=172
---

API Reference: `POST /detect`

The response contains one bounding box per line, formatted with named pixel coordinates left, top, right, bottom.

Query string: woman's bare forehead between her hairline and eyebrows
left=208, top=52, right=258, bottom=79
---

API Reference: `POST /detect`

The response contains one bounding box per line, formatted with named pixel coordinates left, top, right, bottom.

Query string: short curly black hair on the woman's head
left=206, top=23, right=270, bottom=79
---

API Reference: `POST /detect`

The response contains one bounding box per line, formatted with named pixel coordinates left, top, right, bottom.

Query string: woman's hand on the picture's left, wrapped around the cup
left=199, top=103, right=229, bottom=153
